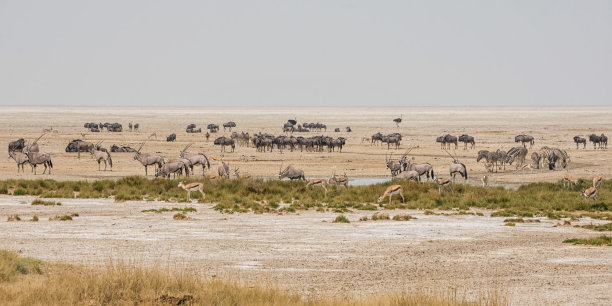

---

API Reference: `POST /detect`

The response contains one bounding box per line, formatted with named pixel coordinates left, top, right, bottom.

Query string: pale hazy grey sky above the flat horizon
left=0, top=0, right=612, bottom=106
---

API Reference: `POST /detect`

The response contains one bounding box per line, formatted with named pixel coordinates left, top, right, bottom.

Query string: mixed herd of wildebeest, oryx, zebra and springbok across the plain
left=3, top=117, right=608, bottom=203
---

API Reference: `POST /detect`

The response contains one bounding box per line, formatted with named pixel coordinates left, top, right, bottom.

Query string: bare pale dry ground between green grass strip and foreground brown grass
left=0, top=196, right=612, bottom=305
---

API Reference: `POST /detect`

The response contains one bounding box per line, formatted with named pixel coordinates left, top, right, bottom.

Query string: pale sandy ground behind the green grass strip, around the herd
left=0, top=107, right=612, bottom=184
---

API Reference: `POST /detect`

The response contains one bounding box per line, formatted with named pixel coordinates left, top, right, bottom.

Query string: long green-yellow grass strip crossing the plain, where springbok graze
left=0, top=176, right=612, bottom=216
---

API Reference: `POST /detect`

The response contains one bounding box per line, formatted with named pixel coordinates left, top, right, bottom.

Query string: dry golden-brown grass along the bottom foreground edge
left=0, top=251, right=507, bottom=306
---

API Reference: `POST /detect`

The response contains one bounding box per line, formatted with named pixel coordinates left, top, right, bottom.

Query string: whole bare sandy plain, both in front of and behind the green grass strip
left=0, top=107, right=612, bottom=305
